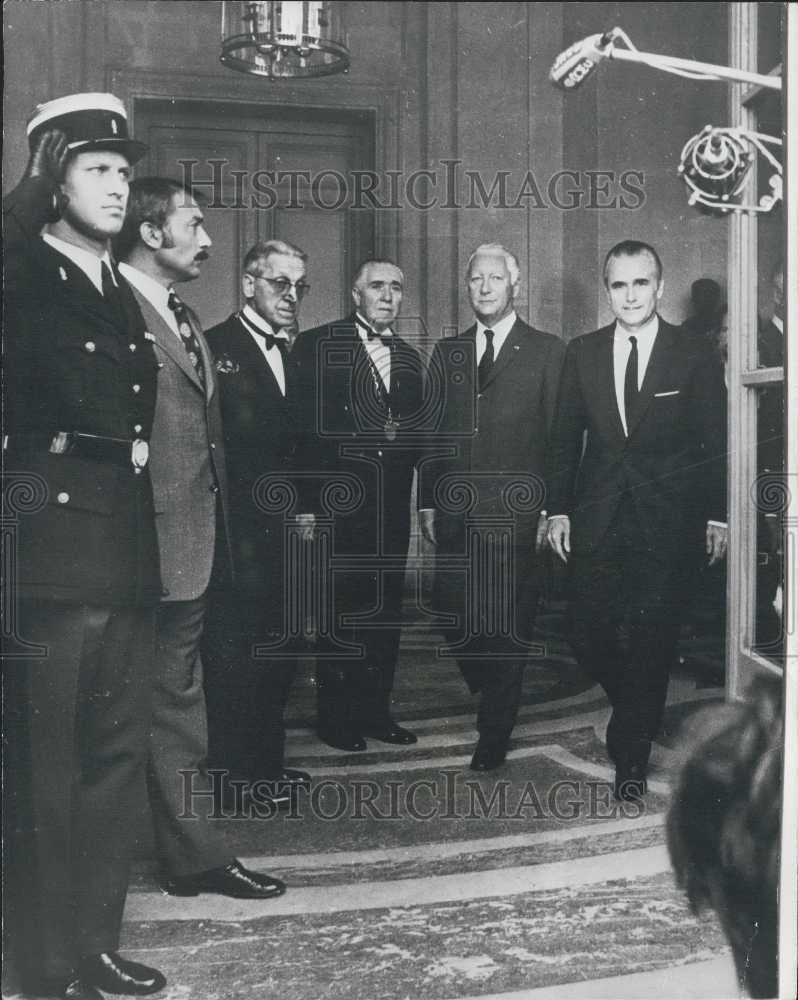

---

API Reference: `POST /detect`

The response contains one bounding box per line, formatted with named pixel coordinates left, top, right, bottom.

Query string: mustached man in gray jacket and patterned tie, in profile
left=116, top=184, right=285, bottom=899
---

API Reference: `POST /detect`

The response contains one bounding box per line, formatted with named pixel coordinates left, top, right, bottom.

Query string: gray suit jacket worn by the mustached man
left=133, top=288, right=227, bottom=601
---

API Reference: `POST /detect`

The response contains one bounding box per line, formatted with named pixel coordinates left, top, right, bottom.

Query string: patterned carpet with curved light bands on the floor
left=106, top=606, right=738, bottom=1000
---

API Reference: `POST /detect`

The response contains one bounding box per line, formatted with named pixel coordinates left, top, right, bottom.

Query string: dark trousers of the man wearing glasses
left=202, top=589, right=296, bottom=781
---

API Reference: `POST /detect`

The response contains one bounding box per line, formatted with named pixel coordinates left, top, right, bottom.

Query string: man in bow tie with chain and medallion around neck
left=291, top=260, right=423, bottom=751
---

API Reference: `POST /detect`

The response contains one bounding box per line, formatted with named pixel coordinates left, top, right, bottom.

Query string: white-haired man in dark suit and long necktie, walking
left=419, top=244, right=565, bottom=771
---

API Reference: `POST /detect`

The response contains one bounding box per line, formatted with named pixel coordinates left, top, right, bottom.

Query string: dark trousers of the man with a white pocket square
left=571, top=501, right=682, bottom=766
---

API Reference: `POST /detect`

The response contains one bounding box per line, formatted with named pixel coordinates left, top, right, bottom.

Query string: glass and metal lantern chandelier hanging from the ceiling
left=219, top=0, right=349, bottom=80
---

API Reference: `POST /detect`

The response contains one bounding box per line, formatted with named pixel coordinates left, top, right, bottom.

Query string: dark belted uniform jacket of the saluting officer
left=3, top=178, right=161, bottom=605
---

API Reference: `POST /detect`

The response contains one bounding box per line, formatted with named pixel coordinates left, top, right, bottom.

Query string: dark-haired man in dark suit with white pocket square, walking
left=548, top=240, right=726, bottom=800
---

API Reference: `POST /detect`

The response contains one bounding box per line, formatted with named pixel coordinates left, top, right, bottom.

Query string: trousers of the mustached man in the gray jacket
left=147, top=596, right=231, bottom=875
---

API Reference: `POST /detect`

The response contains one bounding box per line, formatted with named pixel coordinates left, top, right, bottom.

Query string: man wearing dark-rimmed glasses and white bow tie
left=203, top=240, right=310, bottom=805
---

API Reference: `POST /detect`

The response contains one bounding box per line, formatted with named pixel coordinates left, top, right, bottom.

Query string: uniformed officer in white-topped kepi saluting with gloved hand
left=3, top=94, right=165, bottom=1000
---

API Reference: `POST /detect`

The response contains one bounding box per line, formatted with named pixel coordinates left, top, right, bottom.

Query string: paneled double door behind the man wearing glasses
left=135, top=99, right=374, bottom=329
